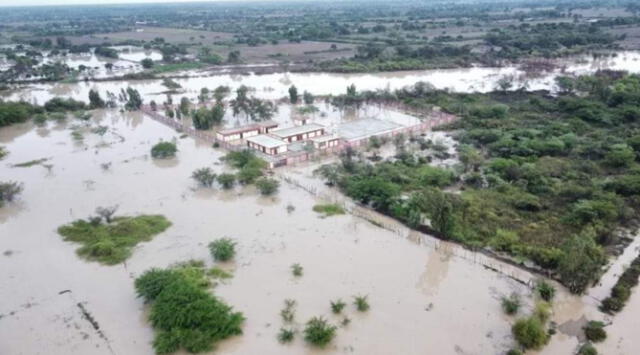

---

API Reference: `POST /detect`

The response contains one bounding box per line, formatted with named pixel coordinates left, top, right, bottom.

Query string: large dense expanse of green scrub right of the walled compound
left=317, top=72, right=640, bottom=293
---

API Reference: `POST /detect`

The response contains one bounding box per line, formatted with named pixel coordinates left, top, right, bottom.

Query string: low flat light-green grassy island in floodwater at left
left=58, top=210, right=171, bottom=265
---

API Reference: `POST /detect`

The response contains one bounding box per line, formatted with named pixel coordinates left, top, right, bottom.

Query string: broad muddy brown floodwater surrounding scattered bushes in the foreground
left=0, top=51, right=640, bottom=354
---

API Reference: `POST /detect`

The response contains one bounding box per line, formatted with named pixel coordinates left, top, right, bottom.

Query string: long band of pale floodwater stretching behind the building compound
left=5, top=51, right=640, bottom=104
